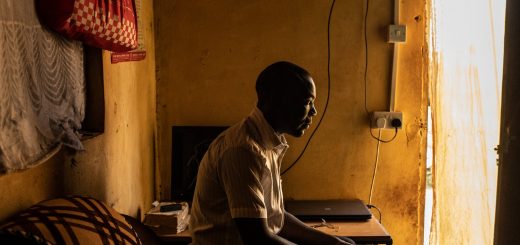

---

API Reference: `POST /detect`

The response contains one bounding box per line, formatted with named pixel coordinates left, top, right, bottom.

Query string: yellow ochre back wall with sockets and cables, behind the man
left=154, top=0, right=427, bottom=244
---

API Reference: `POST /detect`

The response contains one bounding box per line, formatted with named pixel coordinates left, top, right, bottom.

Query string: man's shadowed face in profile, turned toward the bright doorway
left=276, top=77, right=317, bottom=137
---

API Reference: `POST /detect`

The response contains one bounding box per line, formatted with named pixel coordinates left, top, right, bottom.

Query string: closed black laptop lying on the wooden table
left=284, top=199, right=372, bottom=220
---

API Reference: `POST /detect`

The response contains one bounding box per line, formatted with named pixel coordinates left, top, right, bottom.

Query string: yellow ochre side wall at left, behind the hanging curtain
left=0, top=1, right=156, bottom=221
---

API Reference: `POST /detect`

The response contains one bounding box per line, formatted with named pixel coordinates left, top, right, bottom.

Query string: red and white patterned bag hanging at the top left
left=38, top=0, right=138, bottom=52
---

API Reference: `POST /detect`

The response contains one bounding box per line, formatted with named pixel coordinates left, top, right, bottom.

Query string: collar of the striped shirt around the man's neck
left=249, top=107, right=289, bottom=149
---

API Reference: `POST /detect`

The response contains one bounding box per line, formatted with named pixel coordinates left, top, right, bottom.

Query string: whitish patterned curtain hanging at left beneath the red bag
left=0, top=0, right=85, bottom=173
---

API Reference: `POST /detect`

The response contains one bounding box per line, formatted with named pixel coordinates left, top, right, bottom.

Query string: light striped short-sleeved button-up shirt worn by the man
left=189, top=108, right=288, bottom=244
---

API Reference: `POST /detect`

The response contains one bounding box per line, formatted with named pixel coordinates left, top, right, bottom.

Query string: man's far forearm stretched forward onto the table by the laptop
left=278, top=212, right=351, bottom=245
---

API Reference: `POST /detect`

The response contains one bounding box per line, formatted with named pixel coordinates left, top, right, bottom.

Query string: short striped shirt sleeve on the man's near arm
left=219, top=147, right=267, bottom=218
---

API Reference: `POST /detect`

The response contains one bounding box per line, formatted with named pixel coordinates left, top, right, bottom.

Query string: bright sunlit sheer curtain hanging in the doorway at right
left=430, top=0, right=505, bottom=245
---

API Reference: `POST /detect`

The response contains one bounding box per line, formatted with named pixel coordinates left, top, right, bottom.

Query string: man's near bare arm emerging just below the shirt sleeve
left=233, top=218, right=294, bottom=244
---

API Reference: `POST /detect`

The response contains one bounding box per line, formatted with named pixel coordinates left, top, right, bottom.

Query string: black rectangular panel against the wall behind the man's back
left=171, top=126, right=228, bottom=202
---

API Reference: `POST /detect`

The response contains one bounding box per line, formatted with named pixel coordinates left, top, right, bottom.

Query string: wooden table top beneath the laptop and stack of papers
left=161, top=218, right=392, bottom=245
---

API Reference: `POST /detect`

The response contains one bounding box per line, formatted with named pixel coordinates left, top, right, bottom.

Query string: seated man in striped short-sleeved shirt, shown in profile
left=190, top=62, right=353, bottom=244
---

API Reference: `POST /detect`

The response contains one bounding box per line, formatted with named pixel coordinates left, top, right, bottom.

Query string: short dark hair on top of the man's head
left=256, top=61, right=310, bottom=102
